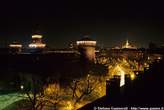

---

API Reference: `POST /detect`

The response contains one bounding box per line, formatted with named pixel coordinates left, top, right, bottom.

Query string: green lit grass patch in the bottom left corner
left=0, top=93, right=23, bottom=110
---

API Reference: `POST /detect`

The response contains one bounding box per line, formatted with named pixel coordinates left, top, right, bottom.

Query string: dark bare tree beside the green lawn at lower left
left=20, top=74, right=45, bottom=110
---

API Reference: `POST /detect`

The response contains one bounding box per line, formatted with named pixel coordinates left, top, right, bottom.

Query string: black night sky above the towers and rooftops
left=0, top=0, right=164, bottom=48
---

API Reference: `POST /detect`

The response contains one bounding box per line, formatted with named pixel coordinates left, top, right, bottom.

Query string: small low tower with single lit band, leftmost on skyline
left=9, top=42, right=22, bottom=53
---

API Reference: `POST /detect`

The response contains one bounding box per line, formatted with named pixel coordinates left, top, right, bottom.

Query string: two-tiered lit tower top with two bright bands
left=29, top=34, right=46, bottom=48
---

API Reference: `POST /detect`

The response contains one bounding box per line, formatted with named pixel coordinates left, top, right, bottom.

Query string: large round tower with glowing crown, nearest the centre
left=76, top=37, right=96, bottom=62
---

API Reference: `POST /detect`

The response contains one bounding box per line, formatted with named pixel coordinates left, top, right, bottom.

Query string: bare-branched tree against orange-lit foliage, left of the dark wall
left=70, top=74, right=99, bottom=108
